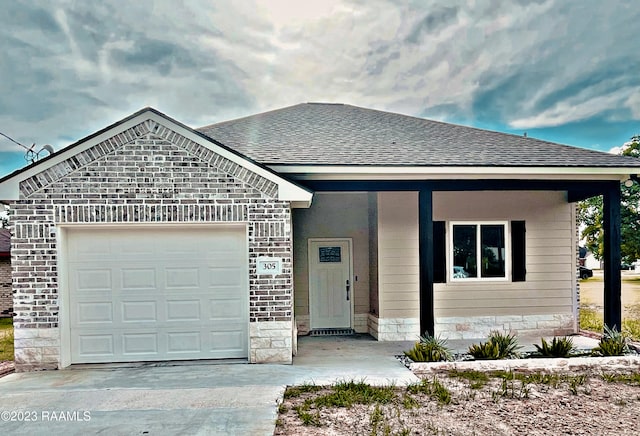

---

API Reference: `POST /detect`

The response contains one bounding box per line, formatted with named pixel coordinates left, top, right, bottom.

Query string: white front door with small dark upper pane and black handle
left=309, top=239, right=353, bottom=329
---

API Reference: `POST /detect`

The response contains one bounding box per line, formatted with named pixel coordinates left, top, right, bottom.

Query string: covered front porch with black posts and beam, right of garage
left=293, top=180, right=620, bottom=341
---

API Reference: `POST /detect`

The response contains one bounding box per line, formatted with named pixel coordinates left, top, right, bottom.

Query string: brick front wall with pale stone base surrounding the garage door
left=11, top=120, right=293, bottom=371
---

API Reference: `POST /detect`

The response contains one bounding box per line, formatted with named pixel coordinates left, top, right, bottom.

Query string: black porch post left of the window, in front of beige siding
left=418, top=188, right=435, bottom=336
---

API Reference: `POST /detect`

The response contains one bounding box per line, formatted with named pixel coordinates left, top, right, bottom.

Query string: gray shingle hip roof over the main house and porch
left=197, top=103, right=640, bottom=168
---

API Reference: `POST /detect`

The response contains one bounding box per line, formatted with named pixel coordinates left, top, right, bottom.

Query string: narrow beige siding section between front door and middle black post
left=378, top=192, right=420, bottom=318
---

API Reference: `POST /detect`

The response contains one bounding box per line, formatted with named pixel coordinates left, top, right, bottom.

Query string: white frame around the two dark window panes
left=447, top=220, right=512, bottom=284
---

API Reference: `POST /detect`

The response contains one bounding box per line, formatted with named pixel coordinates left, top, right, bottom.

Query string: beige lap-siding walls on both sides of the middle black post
left=370, top=191, right=577, bottom=339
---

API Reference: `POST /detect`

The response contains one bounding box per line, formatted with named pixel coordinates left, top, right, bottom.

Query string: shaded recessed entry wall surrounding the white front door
left=293, top=193, right=369, bottom=334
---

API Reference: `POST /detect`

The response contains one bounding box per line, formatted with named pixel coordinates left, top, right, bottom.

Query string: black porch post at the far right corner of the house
left=603, top=182, right=622, bottom=331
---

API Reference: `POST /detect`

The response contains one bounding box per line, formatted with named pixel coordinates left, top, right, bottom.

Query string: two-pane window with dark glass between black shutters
left=451, top=222, right=507, bottom=280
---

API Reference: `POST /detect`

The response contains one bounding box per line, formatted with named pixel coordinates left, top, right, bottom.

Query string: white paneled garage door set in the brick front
left=67, top=227, right=249, bottom=363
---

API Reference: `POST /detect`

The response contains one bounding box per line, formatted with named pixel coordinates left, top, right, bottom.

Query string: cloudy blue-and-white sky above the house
left=0, top=0, right=640, bottom=176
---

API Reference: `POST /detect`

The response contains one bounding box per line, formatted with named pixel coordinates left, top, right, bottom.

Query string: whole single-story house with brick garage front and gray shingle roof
left=0, top=103, right=640, bottom=371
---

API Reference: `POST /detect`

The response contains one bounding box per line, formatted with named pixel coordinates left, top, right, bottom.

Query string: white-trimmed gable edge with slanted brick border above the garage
left=0, top=108, right=311, bottom=206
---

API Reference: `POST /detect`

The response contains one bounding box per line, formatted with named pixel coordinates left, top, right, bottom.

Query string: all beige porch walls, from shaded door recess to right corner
left=293, top=191, right=577, bottom=340
